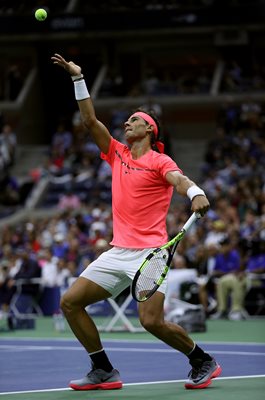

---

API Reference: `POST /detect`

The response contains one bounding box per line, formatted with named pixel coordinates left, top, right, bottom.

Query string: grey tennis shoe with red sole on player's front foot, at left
left=69, top=368, right=122, bottom=390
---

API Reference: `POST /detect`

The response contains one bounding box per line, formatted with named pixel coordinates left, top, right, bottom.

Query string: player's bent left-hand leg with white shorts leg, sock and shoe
left=61, top=252, right=122, bottom=390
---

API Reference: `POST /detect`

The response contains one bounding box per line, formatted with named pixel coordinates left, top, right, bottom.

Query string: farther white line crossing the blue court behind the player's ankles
left=0, top=344, right=265, bottom=357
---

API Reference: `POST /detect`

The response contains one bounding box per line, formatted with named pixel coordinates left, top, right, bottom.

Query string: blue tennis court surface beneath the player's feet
left=0, top=337, right=265, bottom=395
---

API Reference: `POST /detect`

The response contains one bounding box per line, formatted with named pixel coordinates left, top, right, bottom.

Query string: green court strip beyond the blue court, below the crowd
left=0, top=317, right=265, bottom=343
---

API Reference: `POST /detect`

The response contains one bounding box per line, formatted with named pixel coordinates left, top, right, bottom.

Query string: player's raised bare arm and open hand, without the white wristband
left=51, top=54, right=111, bottom=154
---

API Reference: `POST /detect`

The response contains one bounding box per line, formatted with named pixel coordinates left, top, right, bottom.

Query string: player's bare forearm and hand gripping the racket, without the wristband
left=166, top=171, right=210, bottom=216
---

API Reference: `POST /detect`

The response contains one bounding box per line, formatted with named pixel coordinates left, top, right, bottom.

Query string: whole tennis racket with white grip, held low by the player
left=132, top=213, right=201, bottom=302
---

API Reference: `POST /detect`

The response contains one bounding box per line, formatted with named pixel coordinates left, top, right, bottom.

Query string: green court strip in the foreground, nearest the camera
left=0, top=378, right=265, bottom=400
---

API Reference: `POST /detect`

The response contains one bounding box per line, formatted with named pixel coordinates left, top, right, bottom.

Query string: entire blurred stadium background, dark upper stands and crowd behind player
left=0, top=0, right=265, bottom=332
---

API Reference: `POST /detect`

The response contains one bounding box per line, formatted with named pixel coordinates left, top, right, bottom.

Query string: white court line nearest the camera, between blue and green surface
left=0, top=375, right=265, bottom=396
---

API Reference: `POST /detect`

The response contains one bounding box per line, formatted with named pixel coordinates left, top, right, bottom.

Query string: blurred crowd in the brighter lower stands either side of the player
left=0, top=102, right=265, bottom=328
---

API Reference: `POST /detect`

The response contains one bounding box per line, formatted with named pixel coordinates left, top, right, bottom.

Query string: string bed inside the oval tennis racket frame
left=135, top=252, right=167, bottom=300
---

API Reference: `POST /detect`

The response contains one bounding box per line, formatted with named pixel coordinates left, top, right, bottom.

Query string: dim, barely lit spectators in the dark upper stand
left=0, top=49, right=265, bottom=101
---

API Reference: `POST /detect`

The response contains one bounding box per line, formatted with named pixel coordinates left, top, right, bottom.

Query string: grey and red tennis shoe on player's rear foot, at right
left=185, top=359, right=222, bottom=389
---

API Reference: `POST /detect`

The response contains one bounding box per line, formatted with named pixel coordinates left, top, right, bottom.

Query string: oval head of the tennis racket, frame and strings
left=132, top=247, right=168, bottom=302
